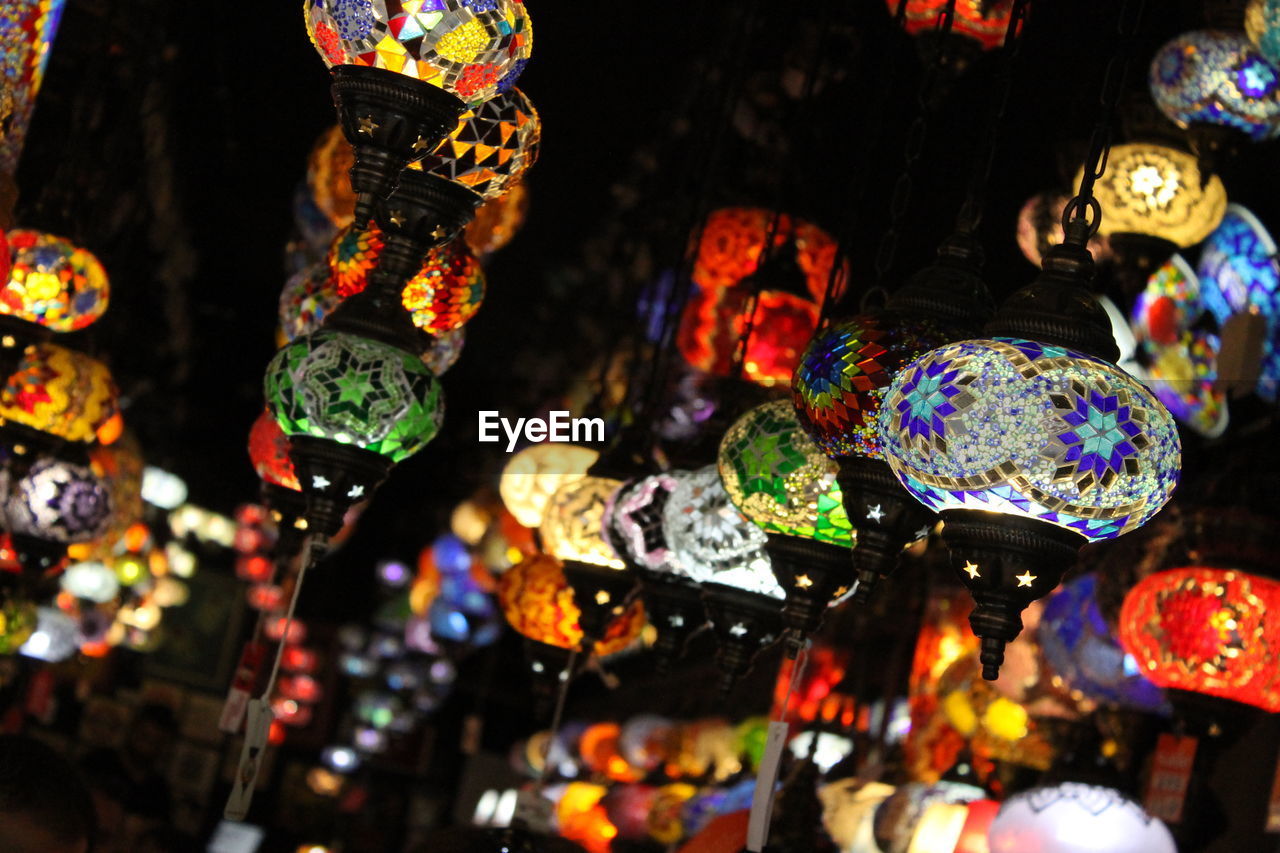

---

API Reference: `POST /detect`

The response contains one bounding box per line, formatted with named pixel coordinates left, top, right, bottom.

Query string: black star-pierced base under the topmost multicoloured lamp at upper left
left=333, top=65, right=466, bottom=225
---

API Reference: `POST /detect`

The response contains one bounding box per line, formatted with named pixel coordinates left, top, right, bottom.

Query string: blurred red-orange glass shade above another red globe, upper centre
left=694, top=207, right=837, bottom=302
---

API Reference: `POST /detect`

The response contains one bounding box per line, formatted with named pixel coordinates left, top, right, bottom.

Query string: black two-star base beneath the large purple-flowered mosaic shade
left=941, top=510, right=1085, bottom=681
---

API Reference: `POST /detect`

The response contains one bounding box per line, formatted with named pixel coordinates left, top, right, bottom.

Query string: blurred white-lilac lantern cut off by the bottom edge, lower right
left=988, top=783, right=1178, bottom=853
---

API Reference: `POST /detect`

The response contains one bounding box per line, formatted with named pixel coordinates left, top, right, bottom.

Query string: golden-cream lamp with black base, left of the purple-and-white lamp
left=539, top=475, right=639, bottom=642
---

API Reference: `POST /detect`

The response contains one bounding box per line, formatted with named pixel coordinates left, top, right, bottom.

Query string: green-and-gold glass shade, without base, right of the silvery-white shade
left=718, top=400, right=854, bottom=547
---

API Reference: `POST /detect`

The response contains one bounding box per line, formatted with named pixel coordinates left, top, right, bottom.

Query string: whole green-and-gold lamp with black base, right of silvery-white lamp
left=718, top=400, right=855, bottom=652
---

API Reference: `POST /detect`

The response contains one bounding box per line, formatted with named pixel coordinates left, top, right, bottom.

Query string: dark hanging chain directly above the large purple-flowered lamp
left=1062, top=0, right=1147, bottom=247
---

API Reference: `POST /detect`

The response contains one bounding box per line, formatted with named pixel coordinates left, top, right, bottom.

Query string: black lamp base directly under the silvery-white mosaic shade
left=703, top=584, right=782, bottom=695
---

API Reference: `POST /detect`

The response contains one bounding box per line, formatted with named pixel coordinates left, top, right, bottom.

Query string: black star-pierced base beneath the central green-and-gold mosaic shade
left=765, top=533, right=854, bottom=658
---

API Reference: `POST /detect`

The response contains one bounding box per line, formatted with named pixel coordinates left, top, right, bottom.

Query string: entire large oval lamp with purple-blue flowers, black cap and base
left=878, top=204, right=1181, bottom=680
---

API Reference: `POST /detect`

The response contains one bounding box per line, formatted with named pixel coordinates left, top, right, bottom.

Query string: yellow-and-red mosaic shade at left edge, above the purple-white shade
left=0, top=343, right=119, bottom=443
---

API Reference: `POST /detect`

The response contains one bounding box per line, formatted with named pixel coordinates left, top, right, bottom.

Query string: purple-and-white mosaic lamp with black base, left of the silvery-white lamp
left=607, top=470, right=707, bottom=674
